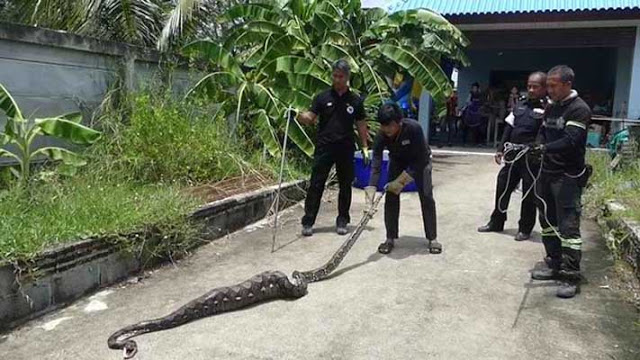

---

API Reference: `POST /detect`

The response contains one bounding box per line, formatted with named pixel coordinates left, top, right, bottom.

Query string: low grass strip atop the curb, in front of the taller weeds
left=0, top=175, right=197, bottom=261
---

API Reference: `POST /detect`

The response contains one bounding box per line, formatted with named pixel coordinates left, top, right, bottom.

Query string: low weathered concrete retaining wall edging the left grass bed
left=0, top=181, right=306, bottom=331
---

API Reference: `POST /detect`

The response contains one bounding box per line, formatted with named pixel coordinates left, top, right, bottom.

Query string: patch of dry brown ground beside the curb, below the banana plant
left=188, top=173, right=277, bottom=203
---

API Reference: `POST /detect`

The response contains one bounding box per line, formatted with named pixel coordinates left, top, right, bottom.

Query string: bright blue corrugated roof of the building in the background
left=389, top=0, right=640, bottom=15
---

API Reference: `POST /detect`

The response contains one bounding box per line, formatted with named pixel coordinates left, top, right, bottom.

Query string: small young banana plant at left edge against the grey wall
left=0, top=84, right=101, bottom=184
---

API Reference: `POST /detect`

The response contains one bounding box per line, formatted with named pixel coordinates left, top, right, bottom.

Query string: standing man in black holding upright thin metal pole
left=298, top=60, right=369, bottom=236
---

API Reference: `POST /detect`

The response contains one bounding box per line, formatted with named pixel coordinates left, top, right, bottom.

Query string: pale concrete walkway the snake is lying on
left=0, top=155, right=640, bottom=360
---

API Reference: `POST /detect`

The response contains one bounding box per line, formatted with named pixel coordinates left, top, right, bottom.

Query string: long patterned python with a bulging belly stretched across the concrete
left=107, top=196, right=382, bottom=359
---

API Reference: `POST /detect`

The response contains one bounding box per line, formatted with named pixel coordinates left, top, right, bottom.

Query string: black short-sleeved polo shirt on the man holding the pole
left=311, top=88, right=366, bottom=147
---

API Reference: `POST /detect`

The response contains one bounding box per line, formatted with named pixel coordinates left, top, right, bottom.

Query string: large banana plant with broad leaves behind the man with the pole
left=172, top=0, right=468, bottom=155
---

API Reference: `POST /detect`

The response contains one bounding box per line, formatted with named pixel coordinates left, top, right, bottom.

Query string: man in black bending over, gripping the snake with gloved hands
left=365, top=103, right=442, bottom=254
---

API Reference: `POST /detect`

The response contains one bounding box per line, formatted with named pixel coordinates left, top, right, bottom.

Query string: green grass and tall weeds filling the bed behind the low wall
left=0, top=92, right=308, bottom=263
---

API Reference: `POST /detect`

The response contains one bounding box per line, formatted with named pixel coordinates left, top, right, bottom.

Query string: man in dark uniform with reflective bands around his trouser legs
left=531, top=65, right=591, bottom=298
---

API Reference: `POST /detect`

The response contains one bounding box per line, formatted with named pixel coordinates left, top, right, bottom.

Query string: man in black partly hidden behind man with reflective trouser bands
left=478, top=72, right=547, bottom=241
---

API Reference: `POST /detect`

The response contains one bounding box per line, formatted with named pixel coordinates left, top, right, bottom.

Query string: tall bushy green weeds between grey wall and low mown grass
left=96, top=93, right=270, bottom=184
